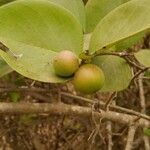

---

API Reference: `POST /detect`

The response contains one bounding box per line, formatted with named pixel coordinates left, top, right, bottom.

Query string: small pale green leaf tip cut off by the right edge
left=135, top=49, right=150, bottom=67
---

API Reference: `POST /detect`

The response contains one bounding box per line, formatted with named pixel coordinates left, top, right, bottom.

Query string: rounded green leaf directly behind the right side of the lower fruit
left=93, top=56, right=132, bottom=92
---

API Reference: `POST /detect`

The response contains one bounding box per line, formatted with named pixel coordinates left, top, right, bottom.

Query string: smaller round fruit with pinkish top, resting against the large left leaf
left=53, top=50, right=79, bottom=77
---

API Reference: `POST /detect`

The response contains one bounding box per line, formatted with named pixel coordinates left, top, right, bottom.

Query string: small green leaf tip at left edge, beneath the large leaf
left=0, top=57, right=13, bottom=78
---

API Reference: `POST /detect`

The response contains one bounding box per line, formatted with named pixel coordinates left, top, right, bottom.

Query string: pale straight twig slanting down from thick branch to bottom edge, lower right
left=125, top=125, right=137, bottom=150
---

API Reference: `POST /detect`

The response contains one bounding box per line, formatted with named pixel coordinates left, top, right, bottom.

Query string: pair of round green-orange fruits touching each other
left=53, top=50, right=105, bottom=94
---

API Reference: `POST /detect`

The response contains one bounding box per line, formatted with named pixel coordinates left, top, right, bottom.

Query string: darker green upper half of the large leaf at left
left=0, top=0, right=83, bottom=53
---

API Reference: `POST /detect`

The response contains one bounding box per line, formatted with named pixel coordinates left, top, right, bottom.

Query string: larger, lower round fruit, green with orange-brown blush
left=73, top=64, right=105, bottom=94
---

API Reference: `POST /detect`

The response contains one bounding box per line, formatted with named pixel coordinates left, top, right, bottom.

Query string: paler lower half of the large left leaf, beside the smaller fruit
left=0, top=38, right=67, bottom=83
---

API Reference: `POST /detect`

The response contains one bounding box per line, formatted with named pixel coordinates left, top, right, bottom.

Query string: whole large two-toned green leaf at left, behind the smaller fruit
left=0, top=0, right=83, bottom=82
